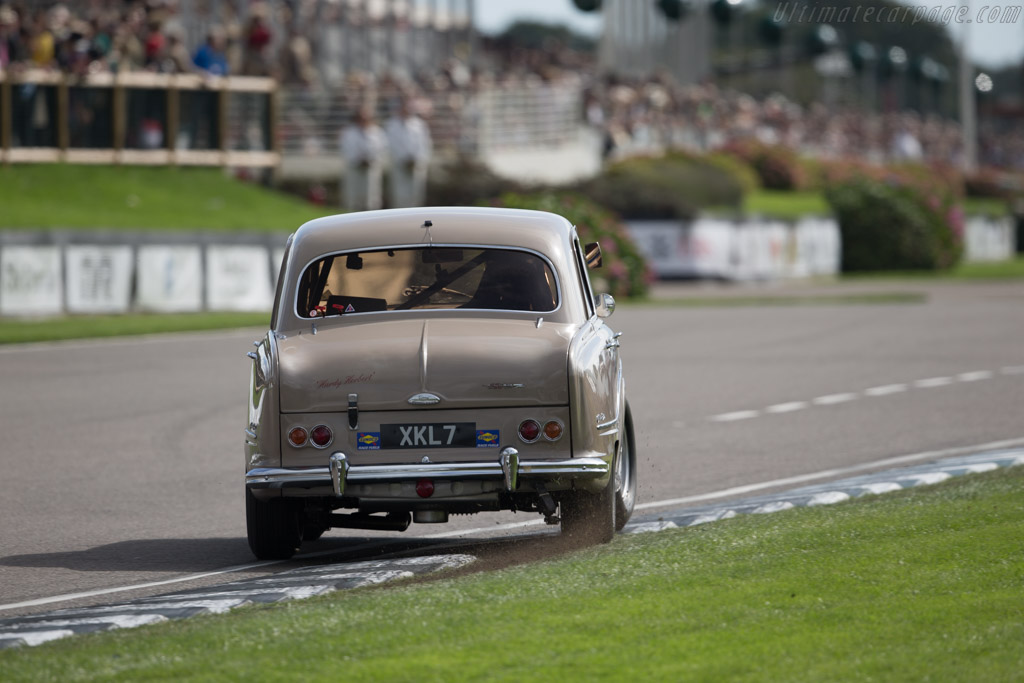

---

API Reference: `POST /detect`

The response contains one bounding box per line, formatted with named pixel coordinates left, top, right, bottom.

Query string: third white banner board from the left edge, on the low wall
left=135, top=245, right=203, bottom=313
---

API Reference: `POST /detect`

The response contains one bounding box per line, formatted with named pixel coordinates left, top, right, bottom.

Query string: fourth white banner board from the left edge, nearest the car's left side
left=206, top=245, right=273, bottom=311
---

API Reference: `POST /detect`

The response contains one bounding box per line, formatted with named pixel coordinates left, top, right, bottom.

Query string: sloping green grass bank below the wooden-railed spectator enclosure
left=0, top=164, right=332, bottom=232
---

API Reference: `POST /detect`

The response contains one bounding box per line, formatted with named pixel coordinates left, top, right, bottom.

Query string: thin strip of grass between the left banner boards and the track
left=0, top=313, right=270, bottom=344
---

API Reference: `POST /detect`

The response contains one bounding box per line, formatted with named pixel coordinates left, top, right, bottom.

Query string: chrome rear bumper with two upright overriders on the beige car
left=246, top=447, right=609, bottom=496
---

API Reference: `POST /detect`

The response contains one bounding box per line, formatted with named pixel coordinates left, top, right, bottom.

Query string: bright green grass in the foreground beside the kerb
left=0, top=468, right=1024, bottom=681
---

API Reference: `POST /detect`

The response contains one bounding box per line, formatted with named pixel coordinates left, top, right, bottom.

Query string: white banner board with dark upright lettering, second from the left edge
left=65, top=245, right=132, bottom=313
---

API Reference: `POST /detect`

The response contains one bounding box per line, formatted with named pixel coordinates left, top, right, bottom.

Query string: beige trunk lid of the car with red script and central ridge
left=279, top=316, right=572, bottom=413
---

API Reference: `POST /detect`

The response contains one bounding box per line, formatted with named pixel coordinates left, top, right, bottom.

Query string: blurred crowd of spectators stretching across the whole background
left=0, top=0, right=1024, bottom=169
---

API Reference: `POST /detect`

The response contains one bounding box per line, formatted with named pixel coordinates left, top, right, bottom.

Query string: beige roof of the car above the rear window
left=292, top=207, right=574, bottom=266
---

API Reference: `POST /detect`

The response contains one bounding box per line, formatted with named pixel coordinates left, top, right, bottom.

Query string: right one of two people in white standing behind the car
left=387, top=101, right=433, bottom=208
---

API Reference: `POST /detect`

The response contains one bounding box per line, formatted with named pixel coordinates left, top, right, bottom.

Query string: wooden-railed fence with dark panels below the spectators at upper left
left=0, top=70, right=280, bottom=167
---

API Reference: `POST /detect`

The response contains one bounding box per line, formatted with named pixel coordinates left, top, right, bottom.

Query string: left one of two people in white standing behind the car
left=340, top=109, right=387, bottom=211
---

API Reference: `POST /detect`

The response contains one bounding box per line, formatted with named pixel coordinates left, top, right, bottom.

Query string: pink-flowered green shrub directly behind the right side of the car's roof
left=489, top=193, right=654, bottom=297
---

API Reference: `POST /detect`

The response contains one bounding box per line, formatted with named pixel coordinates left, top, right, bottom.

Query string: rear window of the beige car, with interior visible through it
left=297, top=247, right=558, bottom=317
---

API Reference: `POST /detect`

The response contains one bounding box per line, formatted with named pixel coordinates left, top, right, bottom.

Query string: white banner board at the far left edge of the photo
left=0, top=247, right=63, bottom=315
